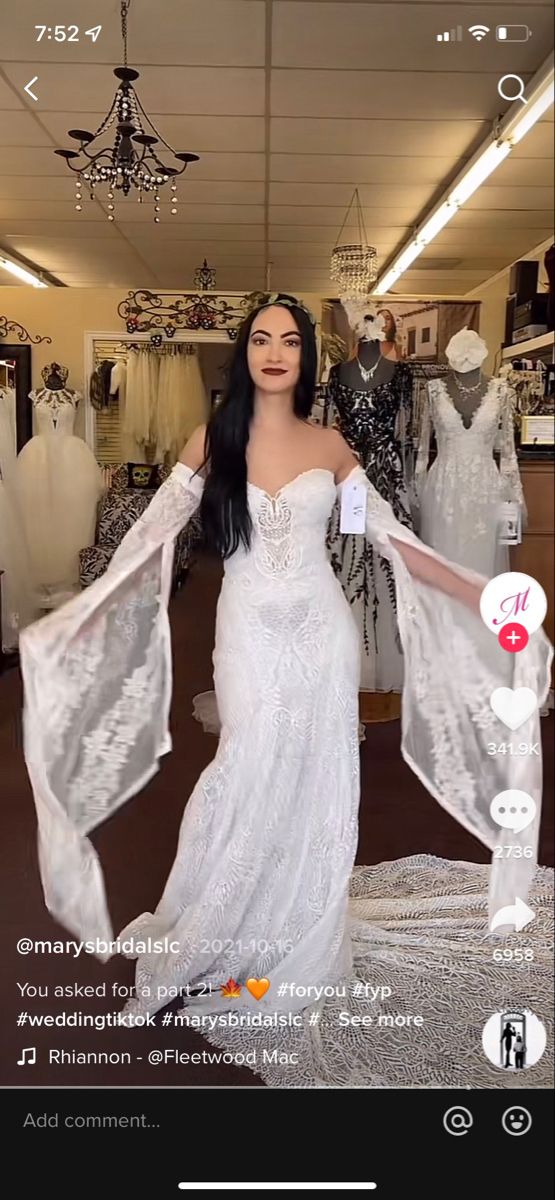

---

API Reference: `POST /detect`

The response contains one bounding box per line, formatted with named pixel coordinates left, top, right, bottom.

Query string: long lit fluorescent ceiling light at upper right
left=372, top=55, right=555, bottom=295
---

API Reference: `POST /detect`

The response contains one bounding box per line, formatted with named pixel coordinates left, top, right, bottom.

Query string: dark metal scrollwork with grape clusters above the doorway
left=118, top=288, right=255, bottom=342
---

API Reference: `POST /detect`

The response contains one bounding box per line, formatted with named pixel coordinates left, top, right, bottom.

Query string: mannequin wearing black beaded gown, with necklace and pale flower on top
left=327, top=301, right=412, bottom=696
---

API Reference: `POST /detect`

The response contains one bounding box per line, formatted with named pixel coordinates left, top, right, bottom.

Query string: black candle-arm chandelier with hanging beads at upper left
left=54, top=0, right=198, bottom=223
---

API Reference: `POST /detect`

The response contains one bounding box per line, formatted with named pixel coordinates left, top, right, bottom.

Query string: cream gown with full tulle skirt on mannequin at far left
left=14, top=388, right=102, bottom=608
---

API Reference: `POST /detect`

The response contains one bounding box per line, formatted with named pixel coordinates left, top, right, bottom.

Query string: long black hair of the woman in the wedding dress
left=201, top=293, right=317, bottom=558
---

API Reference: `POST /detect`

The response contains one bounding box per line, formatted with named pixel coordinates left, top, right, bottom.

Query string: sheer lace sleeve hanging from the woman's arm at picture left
left=20, top=463, right=203, bottom=959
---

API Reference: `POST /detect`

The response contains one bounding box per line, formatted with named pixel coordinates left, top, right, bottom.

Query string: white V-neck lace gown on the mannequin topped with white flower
left=414, top=378, right=524, bottom=578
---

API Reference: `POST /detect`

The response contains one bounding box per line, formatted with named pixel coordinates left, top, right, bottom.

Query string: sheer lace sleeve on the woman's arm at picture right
left=340, top=467, right=553, bottom=931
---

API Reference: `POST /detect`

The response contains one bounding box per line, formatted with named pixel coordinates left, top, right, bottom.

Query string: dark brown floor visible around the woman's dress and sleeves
left=0, top=559, right=554, bottom=1087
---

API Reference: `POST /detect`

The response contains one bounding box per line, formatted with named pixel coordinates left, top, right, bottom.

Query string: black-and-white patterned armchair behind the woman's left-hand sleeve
left=79, top=463, right=201, bottom=588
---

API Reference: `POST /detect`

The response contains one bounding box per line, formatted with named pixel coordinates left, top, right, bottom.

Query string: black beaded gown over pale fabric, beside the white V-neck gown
left=326, top=362, right=412, bottom=691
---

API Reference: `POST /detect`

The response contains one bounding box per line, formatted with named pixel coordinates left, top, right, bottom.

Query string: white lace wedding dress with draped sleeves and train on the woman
left=22, top=463, right=551, bottom=1087
